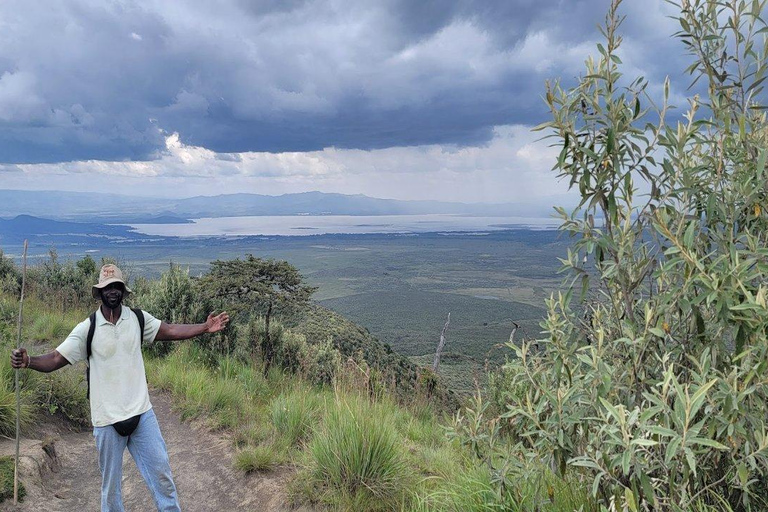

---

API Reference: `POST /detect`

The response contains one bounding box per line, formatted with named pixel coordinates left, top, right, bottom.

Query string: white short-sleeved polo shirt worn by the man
left=56, top=306, right=160, bottom=427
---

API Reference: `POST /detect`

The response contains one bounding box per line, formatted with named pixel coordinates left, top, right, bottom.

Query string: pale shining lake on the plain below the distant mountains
left=126, top=214, right=560, bottom=237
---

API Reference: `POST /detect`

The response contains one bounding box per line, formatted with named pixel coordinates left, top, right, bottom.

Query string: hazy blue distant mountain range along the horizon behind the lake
left=0, top=190, right=551, bottom=220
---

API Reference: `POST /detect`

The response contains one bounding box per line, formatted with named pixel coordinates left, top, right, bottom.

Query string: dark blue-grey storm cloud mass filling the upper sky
left=0, top=0, right=684, bottom=163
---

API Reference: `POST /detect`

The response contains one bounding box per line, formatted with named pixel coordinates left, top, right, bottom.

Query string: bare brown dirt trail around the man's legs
left=0, top=392, right=306, bottom=512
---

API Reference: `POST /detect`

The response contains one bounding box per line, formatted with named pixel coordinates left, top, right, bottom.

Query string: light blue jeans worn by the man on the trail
left=93, top=409, right=181, bottom=512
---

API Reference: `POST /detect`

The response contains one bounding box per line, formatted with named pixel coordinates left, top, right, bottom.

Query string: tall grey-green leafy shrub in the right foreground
left=484, top=0, right=768, bottom=511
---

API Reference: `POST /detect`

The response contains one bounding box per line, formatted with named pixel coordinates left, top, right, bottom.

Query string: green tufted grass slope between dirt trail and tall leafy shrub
left=147, top=344, right=594, bottom=512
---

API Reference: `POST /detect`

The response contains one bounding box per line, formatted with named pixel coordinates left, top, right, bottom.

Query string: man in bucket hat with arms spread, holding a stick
left=11, top=265, right=229, bottom=512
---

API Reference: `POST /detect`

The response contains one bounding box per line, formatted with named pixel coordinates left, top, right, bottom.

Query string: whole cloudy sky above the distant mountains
left=0, top=0, right=689, bottom=203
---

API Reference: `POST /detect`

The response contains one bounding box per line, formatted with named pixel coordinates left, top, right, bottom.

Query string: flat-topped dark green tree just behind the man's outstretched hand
left=201, top=254, right=317, bottom=374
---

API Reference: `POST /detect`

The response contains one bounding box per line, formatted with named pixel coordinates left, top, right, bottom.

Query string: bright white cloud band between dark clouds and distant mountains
left=0, top=125, right=576, bottom=204
